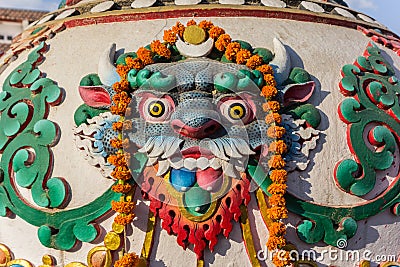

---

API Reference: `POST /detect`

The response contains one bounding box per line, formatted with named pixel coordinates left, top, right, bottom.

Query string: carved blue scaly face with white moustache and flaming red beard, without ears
left=124, top=59, right=272, bottom=254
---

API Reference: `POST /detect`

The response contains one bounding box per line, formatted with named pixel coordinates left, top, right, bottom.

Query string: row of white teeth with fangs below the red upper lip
left=147, top=157, right=245, bottom=179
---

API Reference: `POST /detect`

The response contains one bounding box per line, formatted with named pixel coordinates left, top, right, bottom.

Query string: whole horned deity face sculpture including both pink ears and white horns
left=77, top=25, right=314, bottom=258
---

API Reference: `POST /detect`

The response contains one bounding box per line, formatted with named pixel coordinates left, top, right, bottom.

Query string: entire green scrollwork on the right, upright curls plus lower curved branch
left=256, top=44, right=400, bottom=248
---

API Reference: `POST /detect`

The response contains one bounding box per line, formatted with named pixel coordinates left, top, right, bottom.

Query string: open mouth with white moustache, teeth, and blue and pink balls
left=138, top=136, right=254, bottom=195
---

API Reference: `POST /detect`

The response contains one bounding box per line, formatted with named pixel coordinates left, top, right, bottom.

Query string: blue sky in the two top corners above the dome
left=0, top=0, right=400, bottom=35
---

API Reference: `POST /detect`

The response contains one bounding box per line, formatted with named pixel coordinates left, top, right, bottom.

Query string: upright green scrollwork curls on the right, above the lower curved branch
left=335, top=43, right=400, bottom=196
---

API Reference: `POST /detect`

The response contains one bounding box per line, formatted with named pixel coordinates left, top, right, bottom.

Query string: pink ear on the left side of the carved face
left=79, top=86, right=111, bottom=108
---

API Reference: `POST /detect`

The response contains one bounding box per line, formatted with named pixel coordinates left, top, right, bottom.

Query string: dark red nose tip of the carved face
left=171, top=119, right=220, bottom=139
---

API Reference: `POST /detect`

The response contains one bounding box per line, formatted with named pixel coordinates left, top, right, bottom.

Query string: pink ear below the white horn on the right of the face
left=282, top=81, right=315, bottom=106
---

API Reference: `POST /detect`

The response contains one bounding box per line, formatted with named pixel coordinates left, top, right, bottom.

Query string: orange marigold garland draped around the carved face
left=108, top=20, right=290, bottom=267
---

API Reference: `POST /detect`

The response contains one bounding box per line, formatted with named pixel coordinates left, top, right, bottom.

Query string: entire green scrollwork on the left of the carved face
left=0, top=43, right=147, bottom=250
